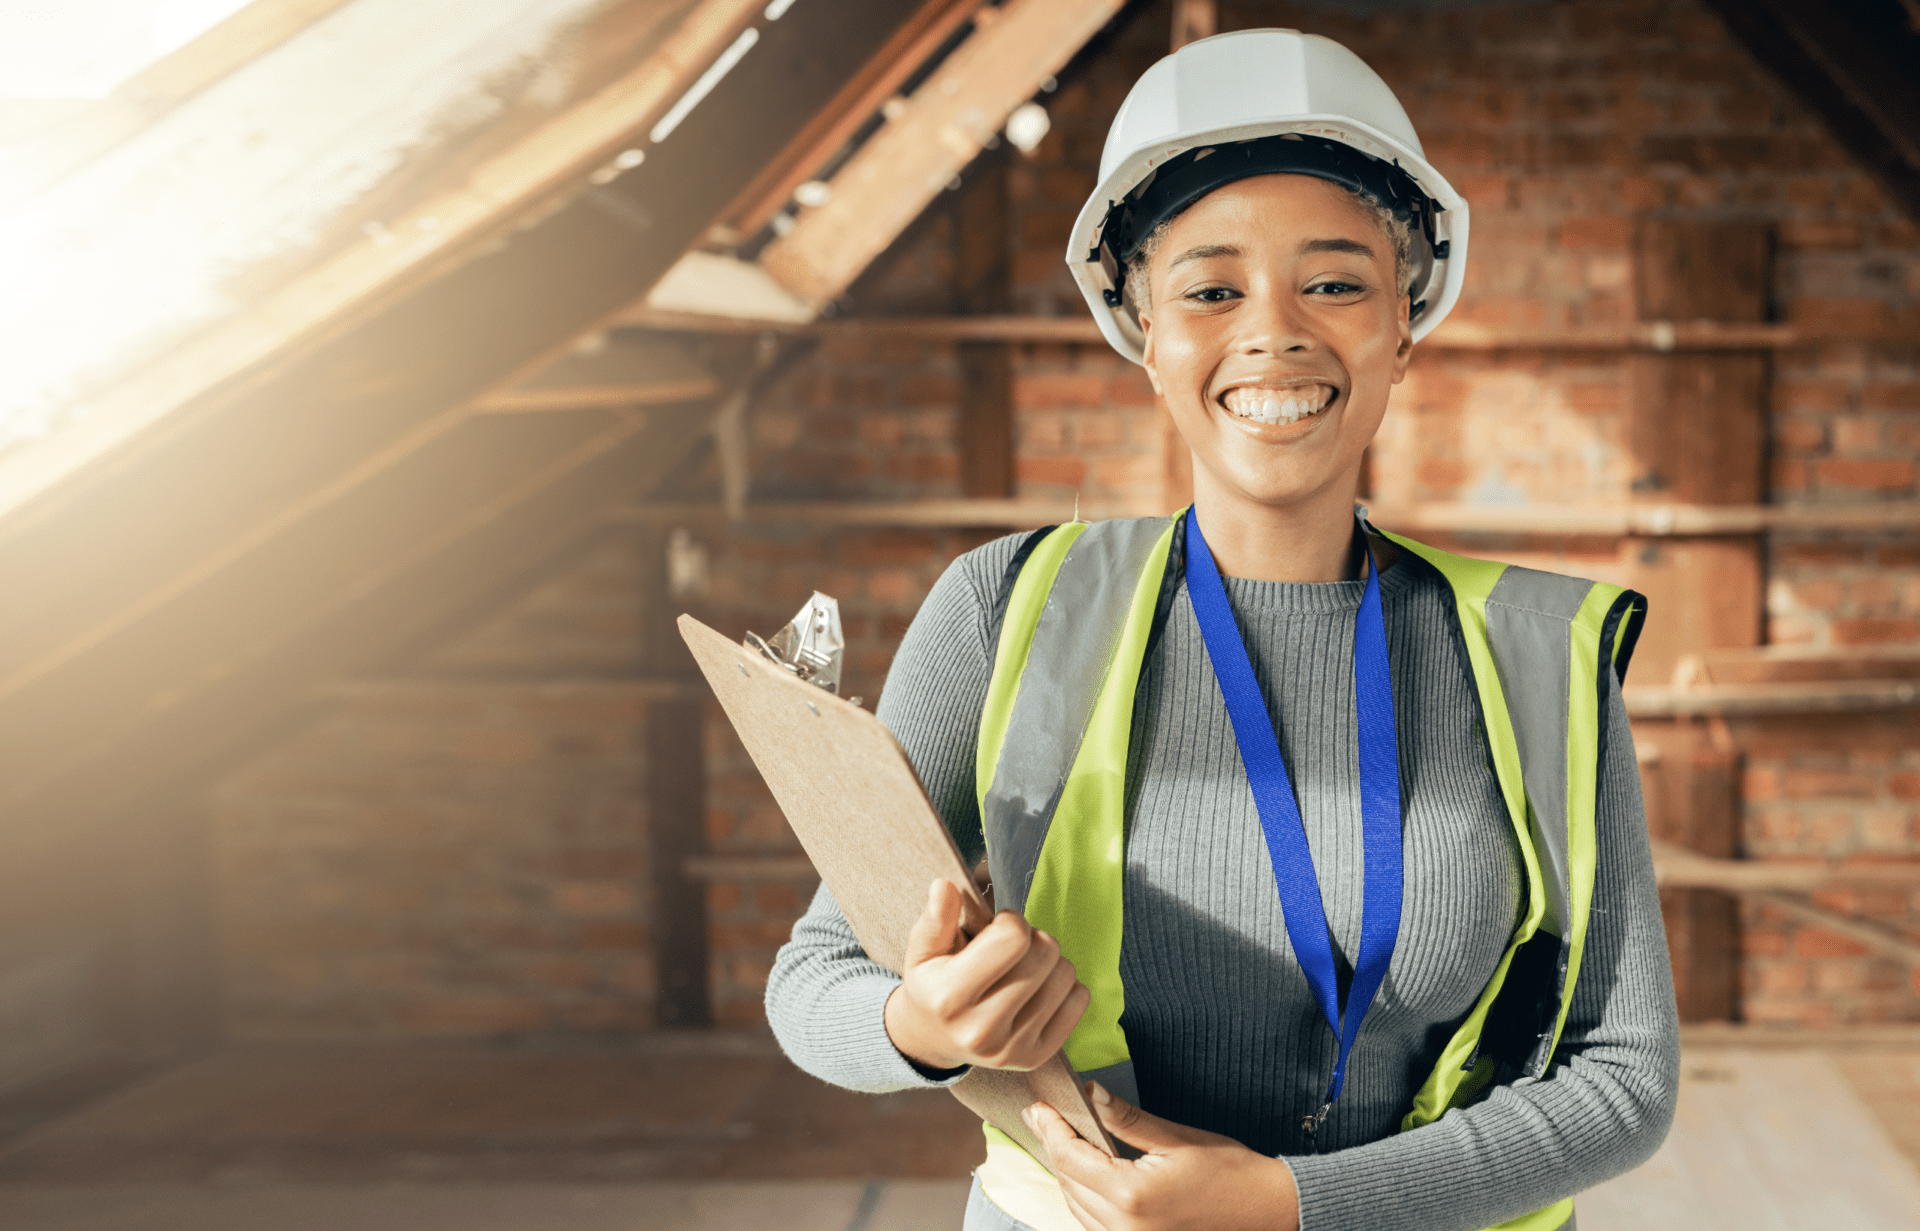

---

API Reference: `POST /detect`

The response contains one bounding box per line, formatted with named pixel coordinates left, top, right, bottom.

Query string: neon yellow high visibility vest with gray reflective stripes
left=975, top=515, right=1645, bottom=1231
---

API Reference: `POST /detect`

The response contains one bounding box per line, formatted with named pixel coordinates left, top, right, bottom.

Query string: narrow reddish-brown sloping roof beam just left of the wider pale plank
left=708, top=0, right=985, bottom=244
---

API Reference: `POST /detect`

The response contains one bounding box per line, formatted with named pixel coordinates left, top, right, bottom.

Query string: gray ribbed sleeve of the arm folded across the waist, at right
left=1288, top=688, right=1680, bottom=1231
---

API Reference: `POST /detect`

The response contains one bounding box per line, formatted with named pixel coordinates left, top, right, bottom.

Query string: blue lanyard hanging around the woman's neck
left=1187, top=509, right=1400, bottom=1139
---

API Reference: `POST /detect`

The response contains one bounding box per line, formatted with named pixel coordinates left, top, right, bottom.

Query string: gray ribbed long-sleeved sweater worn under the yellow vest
left=766, top=538, right=1680, bottom=1231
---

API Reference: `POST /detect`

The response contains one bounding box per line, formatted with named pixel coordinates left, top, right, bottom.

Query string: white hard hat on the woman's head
left=1068, top=31, right=1467, bottom=363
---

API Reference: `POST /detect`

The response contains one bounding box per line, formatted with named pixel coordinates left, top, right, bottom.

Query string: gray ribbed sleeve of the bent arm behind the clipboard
left=766, top=538, right=1020, bottom=1093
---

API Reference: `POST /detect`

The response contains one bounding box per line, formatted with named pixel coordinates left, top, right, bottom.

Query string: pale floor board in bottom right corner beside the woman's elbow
left=1576, top=1049, right=1920, bottom=1231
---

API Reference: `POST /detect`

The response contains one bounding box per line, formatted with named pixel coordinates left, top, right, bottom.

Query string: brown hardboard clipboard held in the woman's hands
left=680, top=615, right=1116, bottom=1164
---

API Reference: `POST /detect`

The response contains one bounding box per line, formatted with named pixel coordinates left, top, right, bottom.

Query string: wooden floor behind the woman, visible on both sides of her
left=0, top=1035, right=1920, bottom=1231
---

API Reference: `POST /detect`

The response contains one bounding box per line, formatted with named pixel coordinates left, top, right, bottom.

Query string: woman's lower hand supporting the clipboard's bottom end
left=1023, top=1081, right=1300, bottom=1231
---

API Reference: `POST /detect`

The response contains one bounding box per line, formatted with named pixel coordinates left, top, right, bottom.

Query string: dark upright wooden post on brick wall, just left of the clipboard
left=639, top=534, right=712, bottom=1029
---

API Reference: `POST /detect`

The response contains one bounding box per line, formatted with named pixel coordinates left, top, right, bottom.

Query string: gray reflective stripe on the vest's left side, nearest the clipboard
left=981, top=517, right=1167, bottom=910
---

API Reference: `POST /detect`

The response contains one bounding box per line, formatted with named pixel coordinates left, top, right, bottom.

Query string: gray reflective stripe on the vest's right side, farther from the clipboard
left=1486, top=567, right=1594, bottom=941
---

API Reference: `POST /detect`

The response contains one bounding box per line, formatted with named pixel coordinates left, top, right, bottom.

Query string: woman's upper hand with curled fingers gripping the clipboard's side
left=885, top=880, right=1091, bottom=1070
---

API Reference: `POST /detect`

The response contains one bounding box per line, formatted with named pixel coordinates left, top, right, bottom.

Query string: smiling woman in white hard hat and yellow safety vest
left=768, top=31, right=1678, bottom=1231
